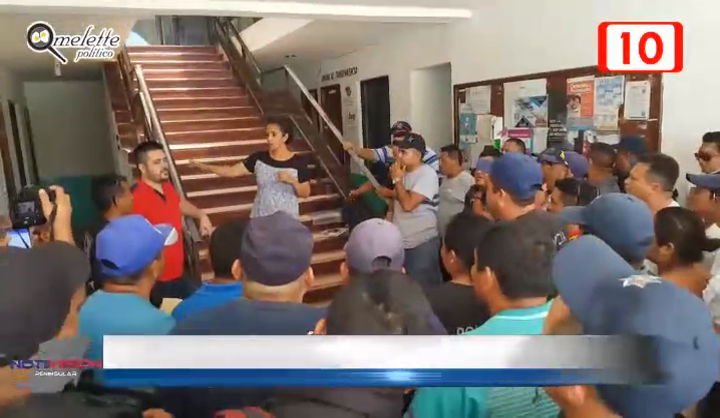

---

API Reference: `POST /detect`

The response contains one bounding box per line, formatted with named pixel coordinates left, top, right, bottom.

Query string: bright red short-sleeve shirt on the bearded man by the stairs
left=133, top=180, right=185, bottom=281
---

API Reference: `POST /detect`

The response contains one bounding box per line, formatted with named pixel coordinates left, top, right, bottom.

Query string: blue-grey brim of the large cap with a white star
left=552, top=235, right=636, bottom=326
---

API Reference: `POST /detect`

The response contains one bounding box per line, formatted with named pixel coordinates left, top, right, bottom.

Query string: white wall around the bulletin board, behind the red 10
left=322, top=0, right=720, bottom=201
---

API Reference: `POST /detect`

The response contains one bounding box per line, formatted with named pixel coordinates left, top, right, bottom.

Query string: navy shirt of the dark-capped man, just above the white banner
left=172, top=299, right=325, bottom=335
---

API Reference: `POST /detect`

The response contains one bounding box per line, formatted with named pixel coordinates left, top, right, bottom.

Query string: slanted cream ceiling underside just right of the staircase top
left=253, top=20, right=436, bottom=69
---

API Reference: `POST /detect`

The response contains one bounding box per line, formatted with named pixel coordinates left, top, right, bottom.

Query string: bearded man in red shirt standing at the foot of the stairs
left=133, top=141, right=213, bottom=301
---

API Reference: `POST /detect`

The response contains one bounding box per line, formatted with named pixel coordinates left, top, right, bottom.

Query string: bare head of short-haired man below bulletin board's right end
left=625, top=153, right=680, bottom=216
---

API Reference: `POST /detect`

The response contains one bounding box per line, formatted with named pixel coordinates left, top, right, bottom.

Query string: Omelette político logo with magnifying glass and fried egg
left=26, top=21, right=121, bottom=64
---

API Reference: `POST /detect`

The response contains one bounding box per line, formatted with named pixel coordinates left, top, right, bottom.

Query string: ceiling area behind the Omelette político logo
left=0, top=13, right=137, bottom=80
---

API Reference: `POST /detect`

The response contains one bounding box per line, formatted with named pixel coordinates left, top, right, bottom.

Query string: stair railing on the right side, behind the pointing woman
left=215, top=18, right=380, bottom=198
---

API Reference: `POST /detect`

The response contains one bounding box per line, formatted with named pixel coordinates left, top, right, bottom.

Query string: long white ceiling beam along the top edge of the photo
left=0, top=0, right=472, bottom=23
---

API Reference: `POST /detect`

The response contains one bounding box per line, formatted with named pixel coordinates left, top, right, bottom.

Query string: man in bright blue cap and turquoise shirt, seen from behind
left=78, top=215, right=178, bottom=377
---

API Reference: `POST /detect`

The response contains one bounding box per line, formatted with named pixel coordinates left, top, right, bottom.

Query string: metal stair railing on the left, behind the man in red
left=112, top=48, right=202, bottom=278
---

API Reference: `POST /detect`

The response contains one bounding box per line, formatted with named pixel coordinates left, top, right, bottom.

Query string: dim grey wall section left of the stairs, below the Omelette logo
left=24, top=81, right=115, bottom=179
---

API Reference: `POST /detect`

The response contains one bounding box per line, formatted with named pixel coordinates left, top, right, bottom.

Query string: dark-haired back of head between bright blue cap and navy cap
left=209, top=220, right=245, bottom=278
